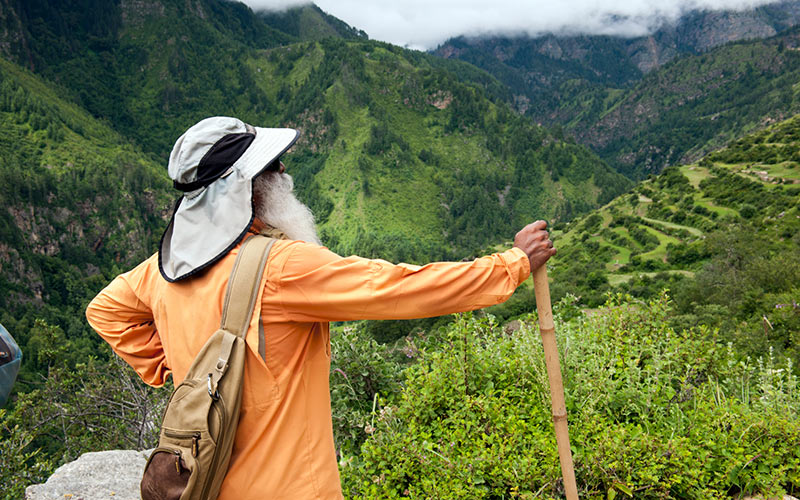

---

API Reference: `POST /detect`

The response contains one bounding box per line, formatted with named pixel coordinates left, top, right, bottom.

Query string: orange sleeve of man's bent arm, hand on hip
left=86, top=262, right=171, bottom=387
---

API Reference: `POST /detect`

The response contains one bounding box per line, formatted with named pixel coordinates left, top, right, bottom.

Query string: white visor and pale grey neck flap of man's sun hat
left=158, top=127, right=300, bottom=282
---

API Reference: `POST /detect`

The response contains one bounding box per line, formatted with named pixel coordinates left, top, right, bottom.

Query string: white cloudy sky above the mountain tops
left=242, top=0, right=775, bottom=50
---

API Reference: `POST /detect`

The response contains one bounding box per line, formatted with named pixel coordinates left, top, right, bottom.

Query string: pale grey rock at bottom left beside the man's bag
left=25, top=450, right=150, bottom=500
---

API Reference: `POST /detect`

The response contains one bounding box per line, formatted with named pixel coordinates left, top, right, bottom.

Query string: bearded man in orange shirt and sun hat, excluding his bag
left=86, top=117, right=555, bottom=500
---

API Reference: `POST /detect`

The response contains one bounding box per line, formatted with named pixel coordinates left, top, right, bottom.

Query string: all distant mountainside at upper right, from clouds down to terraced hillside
left=439, top=2, right=800, bottom=179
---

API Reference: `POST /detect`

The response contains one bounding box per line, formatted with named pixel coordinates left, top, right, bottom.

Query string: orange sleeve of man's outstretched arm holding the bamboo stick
left=277, top=244, right=530, bottom=321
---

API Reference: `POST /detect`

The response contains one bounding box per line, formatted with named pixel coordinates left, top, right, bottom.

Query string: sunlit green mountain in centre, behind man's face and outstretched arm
left=250, top=40, right=628, bottom=260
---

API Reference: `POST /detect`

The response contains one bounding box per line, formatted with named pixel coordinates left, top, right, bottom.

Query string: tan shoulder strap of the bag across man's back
left=208, top=235, right=276, bottom=386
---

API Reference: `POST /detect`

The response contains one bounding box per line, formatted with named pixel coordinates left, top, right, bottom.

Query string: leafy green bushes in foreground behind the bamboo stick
left=341, top=295, right=800, bottom=499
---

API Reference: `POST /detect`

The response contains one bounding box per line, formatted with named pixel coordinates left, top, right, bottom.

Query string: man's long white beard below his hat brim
left=253, top=172, right=321, bottom=245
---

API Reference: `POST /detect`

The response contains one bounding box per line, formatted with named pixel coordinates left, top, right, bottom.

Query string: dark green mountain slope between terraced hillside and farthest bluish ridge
left=565, top=29, right=800, bottom=178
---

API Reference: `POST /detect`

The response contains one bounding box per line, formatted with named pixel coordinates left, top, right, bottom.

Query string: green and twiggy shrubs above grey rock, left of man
left=0, top=320, right=171, bottom=500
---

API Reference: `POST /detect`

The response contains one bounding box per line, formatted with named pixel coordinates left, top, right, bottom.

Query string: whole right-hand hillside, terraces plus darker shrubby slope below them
left=520, top=116, right=800, bottom=361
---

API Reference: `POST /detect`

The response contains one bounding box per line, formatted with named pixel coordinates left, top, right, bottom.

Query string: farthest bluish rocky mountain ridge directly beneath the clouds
left=432, top=0, right=800, bottom=105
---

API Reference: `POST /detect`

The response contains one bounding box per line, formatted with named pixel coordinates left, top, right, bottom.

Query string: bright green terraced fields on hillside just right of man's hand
left=558, top=113, right=800, bottom=300
